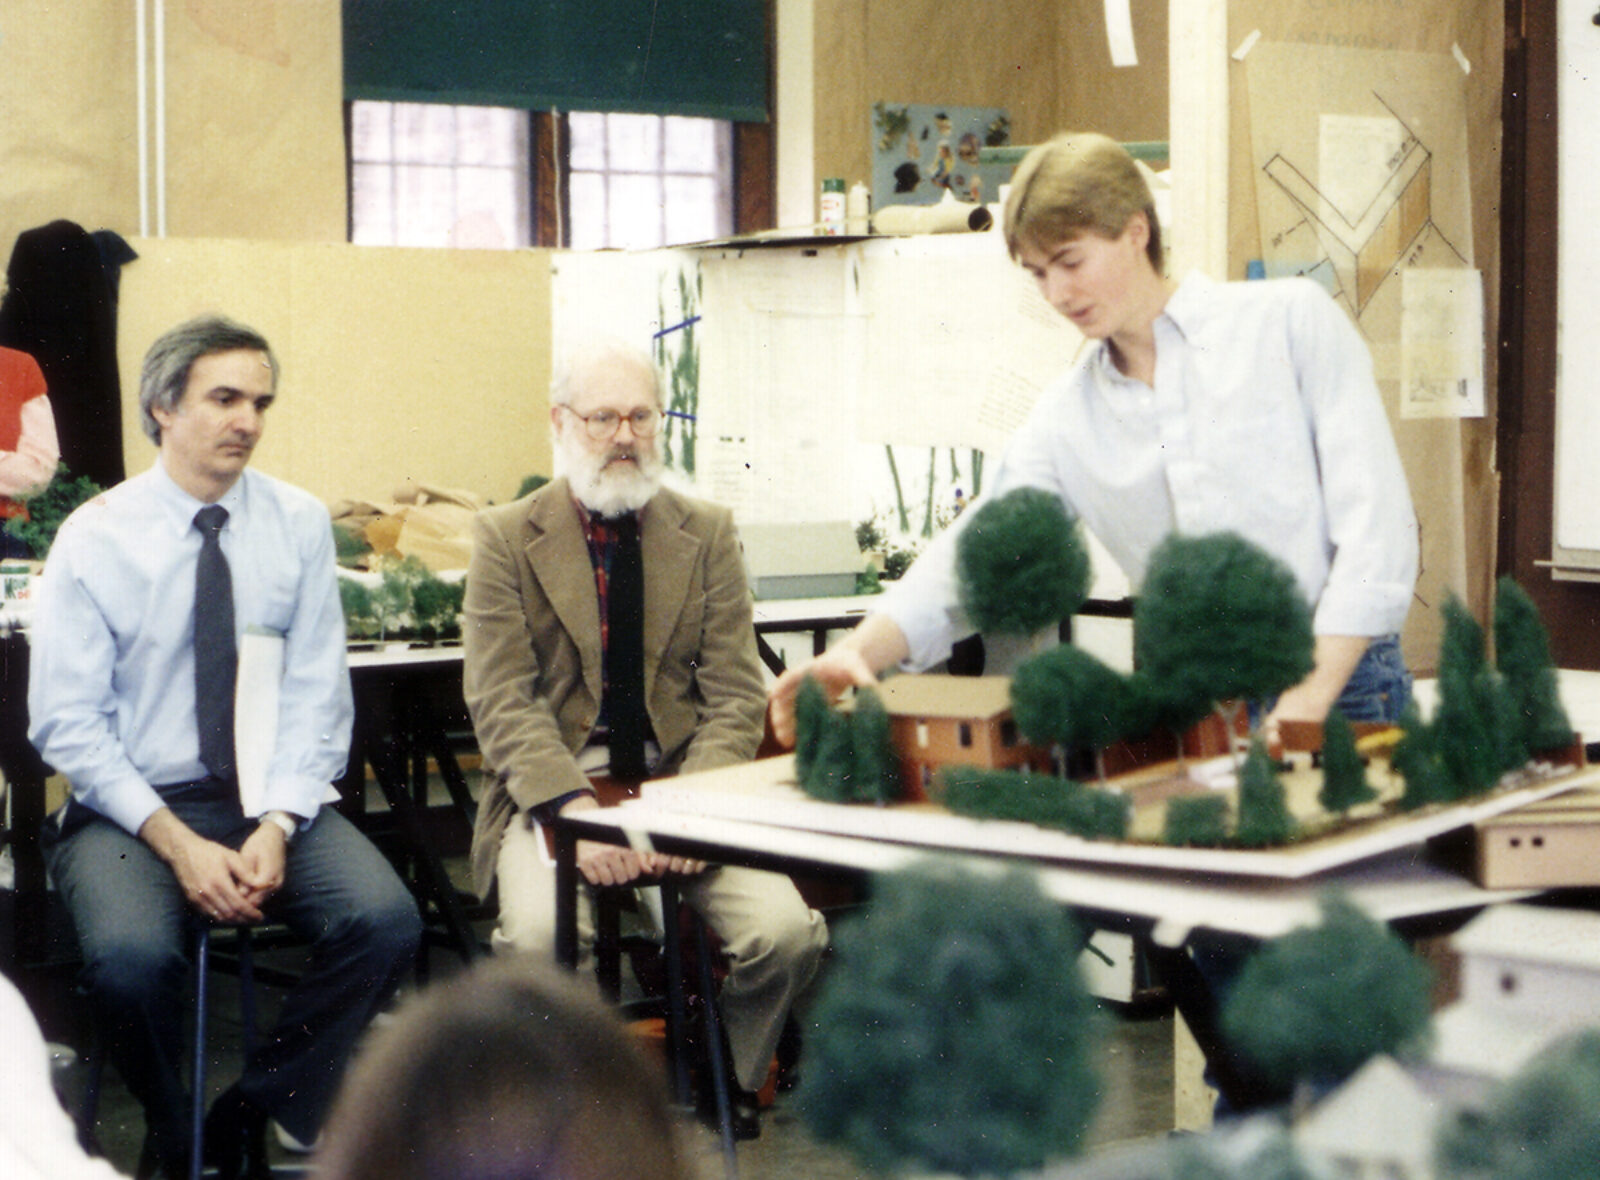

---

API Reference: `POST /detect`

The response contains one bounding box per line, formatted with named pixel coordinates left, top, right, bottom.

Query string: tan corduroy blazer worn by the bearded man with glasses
left=462, top=480, right=766, bottom=894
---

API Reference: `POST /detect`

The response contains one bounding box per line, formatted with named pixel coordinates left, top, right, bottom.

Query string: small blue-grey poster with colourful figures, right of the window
left=870, top=102, right=1013, bottom=209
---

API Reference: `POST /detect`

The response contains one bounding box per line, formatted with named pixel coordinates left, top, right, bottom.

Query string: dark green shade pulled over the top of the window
left=344, top=0, right=768, bottom=122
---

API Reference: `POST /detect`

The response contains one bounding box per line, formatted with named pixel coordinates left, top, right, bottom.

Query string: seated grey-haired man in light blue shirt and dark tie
left=29, top=318, right=421, bottom=1177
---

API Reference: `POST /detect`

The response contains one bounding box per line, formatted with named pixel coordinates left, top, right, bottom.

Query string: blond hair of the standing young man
left=1003, top=131, right=1163, bottom=273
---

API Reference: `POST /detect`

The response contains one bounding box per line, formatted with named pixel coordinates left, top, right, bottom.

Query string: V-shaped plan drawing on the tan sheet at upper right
left=1262, top=94, right=1467, bottom=318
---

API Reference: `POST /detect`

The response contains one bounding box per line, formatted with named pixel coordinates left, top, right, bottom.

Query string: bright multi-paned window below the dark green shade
left=350, top=101, right=734, bottom=249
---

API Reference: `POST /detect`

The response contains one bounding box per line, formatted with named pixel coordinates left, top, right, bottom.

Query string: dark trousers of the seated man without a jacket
left=45, top=780, right=422, bottom=1159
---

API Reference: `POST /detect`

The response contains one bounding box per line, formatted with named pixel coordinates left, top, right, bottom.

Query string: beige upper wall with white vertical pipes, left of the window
left=0, top=0, right=346, bottom=249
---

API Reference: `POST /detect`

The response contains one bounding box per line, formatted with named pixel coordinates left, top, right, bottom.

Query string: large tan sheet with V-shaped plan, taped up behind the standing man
left=1235, top=37, right=1485, bottom=668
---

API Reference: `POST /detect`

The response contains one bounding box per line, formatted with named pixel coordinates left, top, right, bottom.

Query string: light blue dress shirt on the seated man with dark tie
left=27, top=462, right=354, bottom=835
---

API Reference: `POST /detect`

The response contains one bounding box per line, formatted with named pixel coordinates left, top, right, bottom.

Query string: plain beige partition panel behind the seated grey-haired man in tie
left=118, top=238, right=550, bottom=502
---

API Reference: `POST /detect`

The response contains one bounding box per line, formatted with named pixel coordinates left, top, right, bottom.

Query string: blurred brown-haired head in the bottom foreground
left=317, top=958, right=686, bottom=1180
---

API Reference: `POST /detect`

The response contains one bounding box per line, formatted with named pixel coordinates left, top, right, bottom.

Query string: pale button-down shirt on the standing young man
left=880, top=273, right=1418, bottom=670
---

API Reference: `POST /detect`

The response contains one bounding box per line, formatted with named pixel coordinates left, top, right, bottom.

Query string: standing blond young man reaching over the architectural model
left=771, top=134, right=1418, bottom=742
